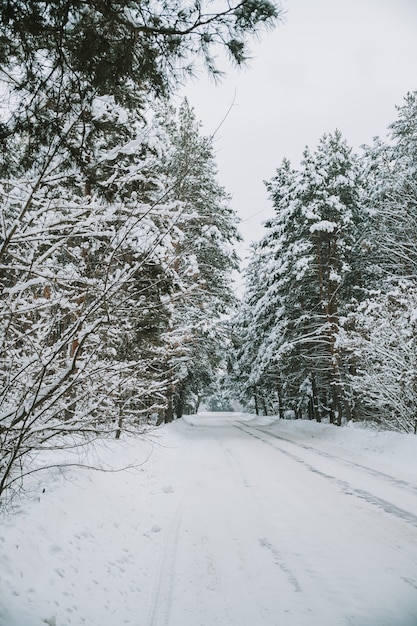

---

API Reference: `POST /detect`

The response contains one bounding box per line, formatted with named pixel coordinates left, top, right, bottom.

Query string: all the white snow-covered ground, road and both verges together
left=0, top=413, right=417, bottom=626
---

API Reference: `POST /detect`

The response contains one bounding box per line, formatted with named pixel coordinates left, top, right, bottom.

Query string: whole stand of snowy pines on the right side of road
left=229, top=92, right=417, bottom=432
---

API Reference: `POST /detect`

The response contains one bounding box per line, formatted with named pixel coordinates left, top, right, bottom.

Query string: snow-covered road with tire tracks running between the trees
left=142, top=413, right=417, bottom=626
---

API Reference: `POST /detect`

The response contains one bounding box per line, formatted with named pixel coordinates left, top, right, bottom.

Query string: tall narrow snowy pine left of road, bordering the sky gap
left=156, top=100, right=239, bottom=419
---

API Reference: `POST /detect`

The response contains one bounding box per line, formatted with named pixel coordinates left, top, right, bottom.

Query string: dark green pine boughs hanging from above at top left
left=0, top=0, right=280, bottom=177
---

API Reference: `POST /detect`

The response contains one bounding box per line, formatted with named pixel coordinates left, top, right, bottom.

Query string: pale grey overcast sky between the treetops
left=180, top=0, right=417, bottom=286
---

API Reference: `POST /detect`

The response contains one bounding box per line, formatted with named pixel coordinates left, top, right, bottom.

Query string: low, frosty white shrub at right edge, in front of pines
left=340, top=280, right=417, bottom=433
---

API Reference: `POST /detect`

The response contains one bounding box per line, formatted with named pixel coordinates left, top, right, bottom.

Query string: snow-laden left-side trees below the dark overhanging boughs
left=0, top=98, right=237, bottom=492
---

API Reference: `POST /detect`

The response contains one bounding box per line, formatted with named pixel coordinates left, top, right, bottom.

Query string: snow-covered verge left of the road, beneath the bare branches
left=0, top=428, right=182, bottom=626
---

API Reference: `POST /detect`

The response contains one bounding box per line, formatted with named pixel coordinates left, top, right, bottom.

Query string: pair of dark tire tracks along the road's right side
left=235, top=424, right=417, bottom=528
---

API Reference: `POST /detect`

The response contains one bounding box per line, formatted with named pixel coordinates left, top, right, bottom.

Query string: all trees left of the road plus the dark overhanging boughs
left=0, top=0, right=280, bottom=494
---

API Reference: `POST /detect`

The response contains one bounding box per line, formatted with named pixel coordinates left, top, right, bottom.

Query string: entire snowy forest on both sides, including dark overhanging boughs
left=0, top=0, right=417, bottom=504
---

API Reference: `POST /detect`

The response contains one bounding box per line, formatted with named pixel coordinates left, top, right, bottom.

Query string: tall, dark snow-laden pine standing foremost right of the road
left=236, top=131, right=363, bottom=423
